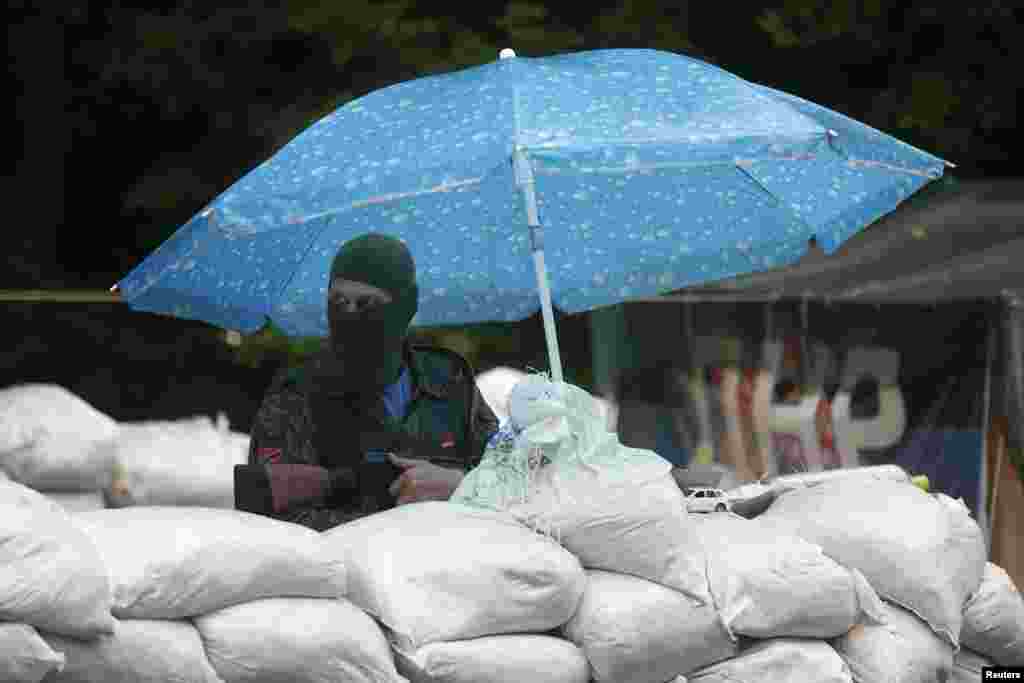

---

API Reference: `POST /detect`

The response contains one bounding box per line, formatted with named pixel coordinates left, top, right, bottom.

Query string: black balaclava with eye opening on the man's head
left=325, top=232, right=419, bottom=393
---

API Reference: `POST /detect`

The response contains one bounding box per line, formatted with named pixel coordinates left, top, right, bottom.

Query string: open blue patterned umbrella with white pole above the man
left=115, top=50, right=945, bottom=380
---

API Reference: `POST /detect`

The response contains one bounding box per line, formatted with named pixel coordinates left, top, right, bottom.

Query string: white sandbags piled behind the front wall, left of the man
left=0, top=384, right=249, bottom=512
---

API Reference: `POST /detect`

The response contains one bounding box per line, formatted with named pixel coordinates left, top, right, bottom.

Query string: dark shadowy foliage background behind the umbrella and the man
left=0, top=0, right=1024, bottom=430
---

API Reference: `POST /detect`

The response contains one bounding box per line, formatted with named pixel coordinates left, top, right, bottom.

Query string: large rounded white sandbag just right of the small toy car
left=758, top=480, right=986, bottom=647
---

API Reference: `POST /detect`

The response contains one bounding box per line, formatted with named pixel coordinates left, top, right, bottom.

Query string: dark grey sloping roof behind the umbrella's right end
left=655, top=179, right=1024, bottom=304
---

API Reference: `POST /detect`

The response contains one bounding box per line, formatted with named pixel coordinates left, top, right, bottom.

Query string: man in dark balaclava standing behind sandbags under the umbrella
left=236, top=233, right=498, bottom=530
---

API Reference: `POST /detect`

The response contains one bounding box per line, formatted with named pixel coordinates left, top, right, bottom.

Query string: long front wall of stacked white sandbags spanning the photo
left=0, top=382, right=1024, bottom=683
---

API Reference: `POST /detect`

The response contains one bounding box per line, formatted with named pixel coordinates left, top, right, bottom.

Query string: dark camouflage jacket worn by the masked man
left=236, top=345, right=498, bottom=530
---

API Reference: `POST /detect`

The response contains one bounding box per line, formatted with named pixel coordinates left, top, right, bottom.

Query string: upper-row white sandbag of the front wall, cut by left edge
left=0, top=481, right=115, bottom=638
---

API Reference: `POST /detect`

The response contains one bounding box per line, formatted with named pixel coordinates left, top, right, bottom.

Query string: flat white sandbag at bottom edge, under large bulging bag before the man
left=395, top=635, right=591, bottom=683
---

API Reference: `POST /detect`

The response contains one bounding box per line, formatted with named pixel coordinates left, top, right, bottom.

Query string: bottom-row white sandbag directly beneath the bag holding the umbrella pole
left=562, top=570, right=739, bottom=683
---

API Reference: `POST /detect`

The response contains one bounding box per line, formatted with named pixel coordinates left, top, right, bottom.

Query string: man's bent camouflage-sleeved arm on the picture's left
left=243, top=370, right=360, bottom=531
